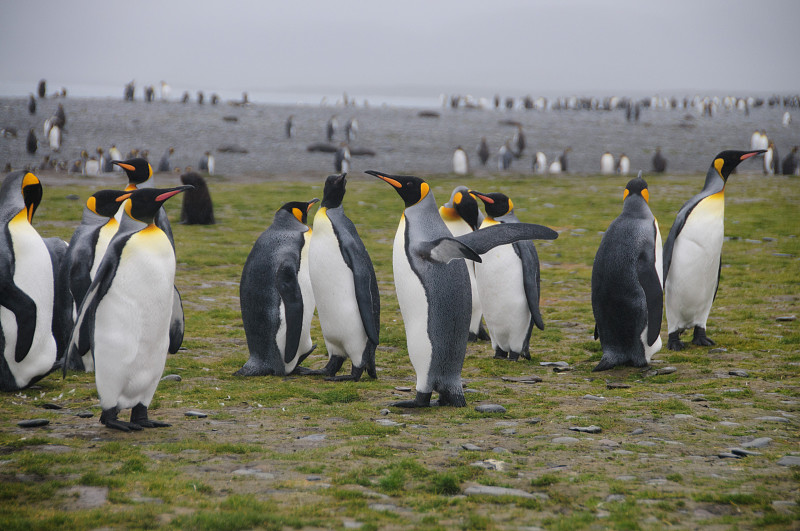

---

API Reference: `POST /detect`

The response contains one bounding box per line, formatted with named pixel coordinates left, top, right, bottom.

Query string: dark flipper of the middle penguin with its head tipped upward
left=336, top=227, right=381, bottom=345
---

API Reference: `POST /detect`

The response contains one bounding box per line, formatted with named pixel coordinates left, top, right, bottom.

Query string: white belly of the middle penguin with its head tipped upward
left=309, top=211, right=367, bottom=367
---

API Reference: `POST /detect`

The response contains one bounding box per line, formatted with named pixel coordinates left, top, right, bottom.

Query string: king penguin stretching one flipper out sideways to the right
left=367, top=171, right=558, bottom=407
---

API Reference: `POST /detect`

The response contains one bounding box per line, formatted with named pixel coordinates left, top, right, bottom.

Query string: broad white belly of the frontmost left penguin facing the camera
left=94, top=227, right=175, bottom=410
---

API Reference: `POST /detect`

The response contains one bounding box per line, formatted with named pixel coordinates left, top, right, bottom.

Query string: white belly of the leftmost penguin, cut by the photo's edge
left=0, top=216, right=56, bottom=387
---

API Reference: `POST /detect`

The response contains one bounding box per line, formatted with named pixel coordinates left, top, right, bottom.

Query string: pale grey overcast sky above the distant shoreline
left=0, top=0, right=800, bottom=96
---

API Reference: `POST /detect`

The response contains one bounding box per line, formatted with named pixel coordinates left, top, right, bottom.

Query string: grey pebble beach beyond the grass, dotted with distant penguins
left=0, top=87, right=800, bottom=178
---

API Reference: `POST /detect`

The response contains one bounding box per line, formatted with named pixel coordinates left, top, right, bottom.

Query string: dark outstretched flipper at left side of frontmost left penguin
left=63, top=232, right=129, bottom=375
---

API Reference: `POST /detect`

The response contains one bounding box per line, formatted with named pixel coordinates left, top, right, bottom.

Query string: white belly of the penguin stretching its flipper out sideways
left=392, top=216, right=433, bottom=393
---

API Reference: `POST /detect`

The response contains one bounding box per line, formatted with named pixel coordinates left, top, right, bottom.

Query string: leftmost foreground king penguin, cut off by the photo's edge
left=0, top=171, right=57, bottom=391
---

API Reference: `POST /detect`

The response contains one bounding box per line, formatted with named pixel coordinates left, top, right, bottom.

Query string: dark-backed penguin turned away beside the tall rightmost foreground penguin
left=592, top=172, right=664, bottom=371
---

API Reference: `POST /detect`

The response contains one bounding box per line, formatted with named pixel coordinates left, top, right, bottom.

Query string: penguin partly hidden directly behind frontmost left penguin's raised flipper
left=61, top=190, right=127, bottom=371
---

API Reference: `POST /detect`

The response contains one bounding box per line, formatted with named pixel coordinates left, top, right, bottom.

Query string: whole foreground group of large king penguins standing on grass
left=0, top=150, right=763, bottom=431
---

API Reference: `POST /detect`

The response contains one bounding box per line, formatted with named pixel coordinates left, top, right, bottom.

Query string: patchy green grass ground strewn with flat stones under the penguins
left=0, top=169, right=800, bottom=529
